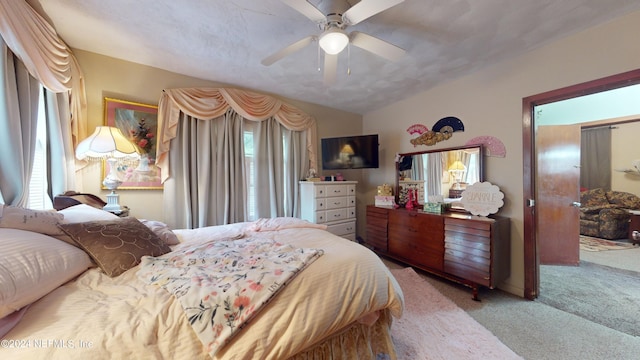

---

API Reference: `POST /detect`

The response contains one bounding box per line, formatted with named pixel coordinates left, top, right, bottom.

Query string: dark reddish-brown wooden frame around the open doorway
left=522, top=69, right=640, bottom=300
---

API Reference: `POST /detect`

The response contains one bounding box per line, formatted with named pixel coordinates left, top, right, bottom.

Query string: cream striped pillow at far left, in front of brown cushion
left=0, top=228, right=92, bottom=318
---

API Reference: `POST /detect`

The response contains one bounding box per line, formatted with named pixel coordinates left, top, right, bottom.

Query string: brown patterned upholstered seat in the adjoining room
left=580, top=189, right=640, bottom=239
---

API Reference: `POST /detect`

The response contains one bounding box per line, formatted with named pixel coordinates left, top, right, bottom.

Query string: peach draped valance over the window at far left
left=0, top=0, right=87, bottom=146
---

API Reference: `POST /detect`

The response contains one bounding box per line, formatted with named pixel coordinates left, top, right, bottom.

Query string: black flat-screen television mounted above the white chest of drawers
left=321, top=134, right=378, bottom=170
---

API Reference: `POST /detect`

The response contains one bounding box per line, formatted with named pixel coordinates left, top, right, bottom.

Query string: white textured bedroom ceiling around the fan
left=28, top=0, right=640, bottom=114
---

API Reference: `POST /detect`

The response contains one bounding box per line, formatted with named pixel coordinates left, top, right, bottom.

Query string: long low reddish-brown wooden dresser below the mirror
left=365, top=205, right=511, bottom=300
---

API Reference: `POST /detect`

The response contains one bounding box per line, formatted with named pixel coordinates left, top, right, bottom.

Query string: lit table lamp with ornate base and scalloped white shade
left=76, top=126, right=140, bottom=214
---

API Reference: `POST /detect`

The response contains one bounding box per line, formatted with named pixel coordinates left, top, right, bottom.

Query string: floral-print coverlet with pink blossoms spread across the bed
left=137, top=237, right=323, bottom=357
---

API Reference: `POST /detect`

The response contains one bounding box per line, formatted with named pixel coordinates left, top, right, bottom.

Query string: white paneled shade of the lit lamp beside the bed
left=76, top=126, right=140, bottom=160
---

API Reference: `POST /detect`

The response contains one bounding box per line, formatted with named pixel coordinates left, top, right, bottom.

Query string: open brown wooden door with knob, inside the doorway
left=535, top=125, right=580, bottom=266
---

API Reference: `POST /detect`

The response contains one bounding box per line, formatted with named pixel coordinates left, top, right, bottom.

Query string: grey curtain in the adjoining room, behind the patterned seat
left=580, top=126, right=611, bottom=190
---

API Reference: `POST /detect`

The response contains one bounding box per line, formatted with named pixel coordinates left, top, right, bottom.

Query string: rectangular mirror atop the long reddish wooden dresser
left=395, top=145, right=484, bottom=211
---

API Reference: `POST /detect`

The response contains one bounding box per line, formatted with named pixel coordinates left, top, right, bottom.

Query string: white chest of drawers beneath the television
left=300, top=181, right=358, bottom=241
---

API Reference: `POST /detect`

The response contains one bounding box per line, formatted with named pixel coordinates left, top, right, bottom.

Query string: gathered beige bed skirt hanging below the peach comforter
left=289, top=309, right=397, bottom=360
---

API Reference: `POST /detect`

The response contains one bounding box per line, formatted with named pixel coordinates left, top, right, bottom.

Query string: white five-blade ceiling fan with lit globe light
left=262, top=0, right=405, bottom=85
